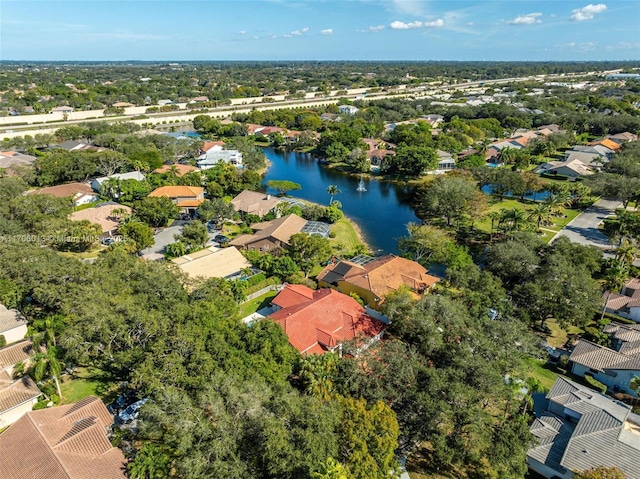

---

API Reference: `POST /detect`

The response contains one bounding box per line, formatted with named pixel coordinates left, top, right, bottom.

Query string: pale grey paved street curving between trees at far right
left=552, top=200, right=622, bottom=249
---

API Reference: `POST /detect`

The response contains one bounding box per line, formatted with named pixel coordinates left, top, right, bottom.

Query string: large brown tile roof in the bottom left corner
left=0, top=396, right=126, bottom=479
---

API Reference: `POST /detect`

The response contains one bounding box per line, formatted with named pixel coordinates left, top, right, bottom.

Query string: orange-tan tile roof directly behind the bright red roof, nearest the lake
left=318, top=254, right=440, bottom=299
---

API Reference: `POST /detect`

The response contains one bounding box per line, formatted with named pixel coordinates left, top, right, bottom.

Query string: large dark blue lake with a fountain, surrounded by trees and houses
left=264, top=148, right=420, bottom=254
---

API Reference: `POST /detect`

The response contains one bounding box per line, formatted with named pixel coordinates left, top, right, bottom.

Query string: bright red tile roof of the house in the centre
left=269, top=285, right=387, bottom=354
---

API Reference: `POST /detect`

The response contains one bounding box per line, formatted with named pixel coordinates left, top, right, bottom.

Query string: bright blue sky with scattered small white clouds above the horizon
left=0, top=0, right=640, bottom=61
